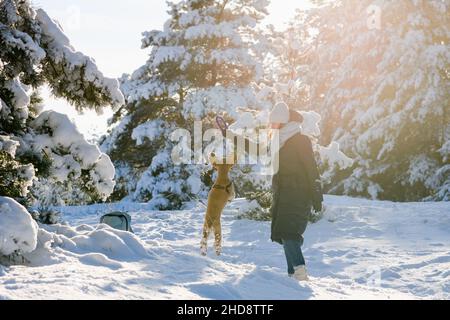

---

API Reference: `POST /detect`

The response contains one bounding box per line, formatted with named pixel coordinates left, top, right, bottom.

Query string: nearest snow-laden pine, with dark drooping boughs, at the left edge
left=0, top=0, right=124, bottom=204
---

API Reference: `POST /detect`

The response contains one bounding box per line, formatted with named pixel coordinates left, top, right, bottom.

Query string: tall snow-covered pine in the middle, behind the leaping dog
left=103, top=0, right=267, bottom=209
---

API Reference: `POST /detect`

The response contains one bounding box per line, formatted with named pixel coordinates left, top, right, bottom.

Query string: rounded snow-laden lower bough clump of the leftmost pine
left=23, top=111, right=115, bottom=204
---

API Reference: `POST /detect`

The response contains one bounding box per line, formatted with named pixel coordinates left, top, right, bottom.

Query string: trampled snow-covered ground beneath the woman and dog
left=0, top=196, right=450, bottom=299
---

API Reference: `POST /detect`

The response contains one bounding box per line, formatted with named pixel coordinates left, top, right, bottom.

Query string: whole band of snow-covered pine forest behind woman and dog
left=0, top=0, right=450, bottom=214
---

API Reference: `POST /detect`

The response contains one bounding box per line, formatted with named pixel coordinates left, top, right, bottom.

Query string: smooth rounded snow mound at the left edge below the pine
left=0, top=197, right=38, bottom=255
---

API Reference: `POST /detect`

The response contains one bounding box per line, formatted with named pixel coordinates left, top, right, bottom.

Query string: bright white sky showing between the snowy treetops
left=32, top=0, right=309, bottom=136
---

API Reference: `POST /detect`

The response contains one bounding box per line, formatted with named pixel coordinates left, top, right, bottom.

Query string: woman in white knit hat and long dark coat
left=269, top=103, right=323, bottom=281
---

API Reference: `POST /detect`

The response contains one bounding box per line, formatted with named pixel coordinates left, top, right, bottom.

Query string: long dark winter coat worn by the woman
left=271, top=133, right=323, bottom=243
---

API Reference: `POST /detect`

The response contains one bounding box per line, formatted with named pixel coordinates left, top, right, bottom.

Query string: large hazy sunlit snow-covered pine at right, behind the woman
left=294, top=0, right=450, bottom=201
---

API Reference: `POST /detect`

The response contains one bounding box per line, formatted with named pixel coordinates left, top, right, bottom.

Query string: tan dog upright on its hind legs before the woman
left=200, top=153, right=235, bottom=256
